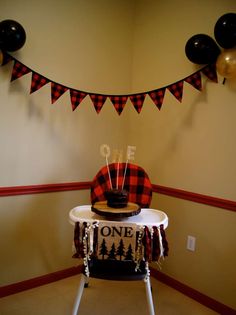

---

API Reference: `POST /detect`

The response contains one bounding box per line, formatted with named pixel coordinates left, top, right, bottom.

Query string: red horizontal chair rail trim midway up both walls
left=0, top=181, right=236, bottom=211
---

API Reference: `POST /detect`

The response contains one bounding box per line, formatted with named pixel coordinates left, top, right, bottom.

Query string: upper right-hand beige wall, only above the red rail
left=130, top=1, right=236, bottom=199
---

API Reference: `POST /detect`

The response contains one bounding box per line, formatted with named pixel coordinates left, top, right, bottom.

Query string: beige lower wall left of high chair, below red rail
left=0, top=191, right=89, bottom=285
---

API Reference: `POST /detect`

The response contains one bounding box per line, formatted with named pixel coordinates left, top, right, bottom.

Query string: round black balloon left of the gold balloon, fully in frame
left=185, top=34, right=220, bottom=64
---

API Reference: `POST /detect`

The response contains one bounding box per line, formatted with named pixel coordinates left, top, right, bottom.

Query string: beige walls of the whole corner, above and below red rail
left=0, top=0, right=236, bottom=307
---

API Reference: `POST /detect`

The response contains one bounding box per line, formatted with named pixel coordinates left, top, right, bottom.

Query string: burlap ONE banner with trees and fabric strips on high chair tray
left=72, top=221, right=169, bottom=264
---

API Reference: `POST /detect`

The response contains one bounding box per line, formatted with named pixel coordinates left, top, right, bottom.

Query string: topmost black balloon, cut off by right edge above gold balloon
left=214, top=13, right=236, bottom=48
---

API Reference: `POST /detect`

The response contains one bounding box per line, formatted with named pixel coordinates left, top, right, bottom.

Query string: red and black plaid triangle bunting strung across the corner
left=2, top=52, right=218, bottom=115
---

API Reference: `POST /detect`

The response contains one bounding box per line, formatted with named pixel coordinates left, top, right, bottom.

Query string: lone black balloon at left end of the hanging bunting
left=0, top=20, right=26, bottom=51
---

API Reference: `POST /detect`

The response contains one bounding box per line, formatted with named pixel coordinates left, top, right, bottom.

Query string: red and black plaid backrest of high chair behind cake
left=91, top=163, right=152, bottom=208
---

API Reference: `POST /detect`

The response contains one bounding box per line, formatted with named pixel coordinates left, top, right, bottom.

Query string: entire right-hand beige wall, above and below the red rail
left=129, top=0, right=236, bottom=308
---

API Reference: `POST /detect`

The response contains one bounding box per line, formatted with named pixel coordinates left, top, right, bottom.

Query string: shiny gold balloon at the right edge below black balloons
left=216, top=48, right=236, bottom=79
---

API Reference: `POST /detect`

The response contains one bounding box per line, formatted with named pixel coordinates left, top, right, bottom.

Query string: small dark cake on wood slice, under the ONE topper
left=105, top=189, right=128, bottom=208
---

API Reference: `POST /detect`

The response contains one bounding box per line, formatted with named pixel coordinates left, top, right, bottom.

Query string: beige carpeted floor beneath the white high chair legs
left=0, top=275, right=217, bottom=315
